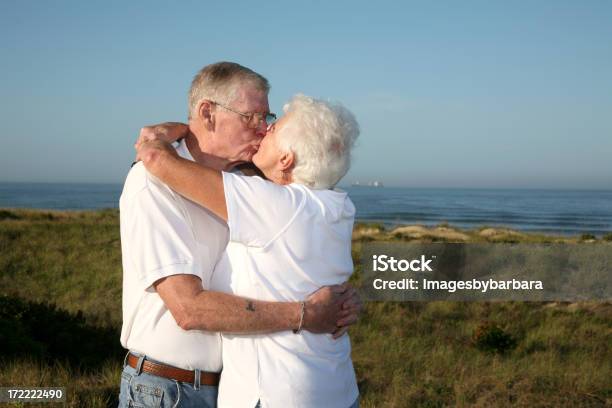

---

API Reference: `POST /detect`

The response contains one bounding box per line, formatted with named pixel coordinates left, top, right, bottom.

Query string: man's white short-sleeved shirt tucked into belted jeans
left=119, top=141, right=228, bottom=372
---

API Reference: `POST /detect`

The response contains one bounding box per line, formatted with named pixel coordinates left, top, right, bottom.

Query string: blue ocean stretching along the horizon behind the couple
left=0, top=183, right=612, bottom=236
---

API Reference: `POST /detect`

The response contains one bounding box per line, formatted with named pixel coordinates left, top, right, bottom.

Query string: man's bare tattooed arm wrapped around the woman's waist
left=155, top=275, right=356, bottom=333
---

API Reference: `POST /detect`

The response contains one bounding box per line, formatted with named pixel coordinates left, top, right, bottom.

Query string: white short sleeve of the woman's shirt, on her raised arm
left=223, top=172, right=305, bottom=247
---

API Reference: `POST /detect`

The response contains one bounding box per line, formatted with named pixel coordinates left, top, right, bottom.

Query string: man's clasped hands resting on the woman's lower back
left=304, top=283, right=361, bottom=338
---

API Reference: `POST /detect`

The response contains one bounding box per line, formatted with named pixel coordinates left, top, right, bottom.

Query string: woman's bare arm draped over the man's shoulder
left=136, top=140, right=227, bottom=221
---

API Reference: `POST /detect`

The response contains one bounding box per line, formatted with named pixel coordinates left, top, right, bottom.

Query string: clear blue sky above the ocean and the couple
left=0, top=0, right=612, bottom=189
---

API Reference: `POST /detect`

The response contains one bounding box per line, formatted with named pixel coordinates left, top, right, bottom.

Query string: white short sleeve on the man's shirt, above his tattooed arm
left=120, top=175, right=203, bottom=289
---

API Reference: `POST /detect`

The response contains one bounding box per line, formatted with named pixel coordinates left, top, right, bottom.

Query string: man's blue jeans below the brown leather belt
left=119, top=352, right=219, bottom=408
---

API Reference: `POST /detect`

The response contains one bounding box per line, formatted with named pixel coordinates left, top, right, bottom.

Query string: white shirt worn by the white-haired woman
left=215, top=173, right=359, bottom=408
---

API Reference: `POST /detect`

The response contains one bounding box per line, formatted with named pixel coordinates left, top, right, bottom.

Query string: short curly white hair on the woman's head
left=279, top=94, right=359, bottom=189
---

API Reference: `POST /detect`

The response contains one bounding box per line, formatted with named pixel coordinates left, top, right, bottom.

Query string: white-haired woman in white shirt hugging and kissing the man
left=137, top=95, right=359, bottom=408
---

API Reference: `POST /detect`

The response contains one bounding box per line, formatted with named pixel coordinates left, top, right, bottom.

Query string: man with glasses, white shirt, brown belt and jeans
left=119, top=62, right=359, bottom=407
